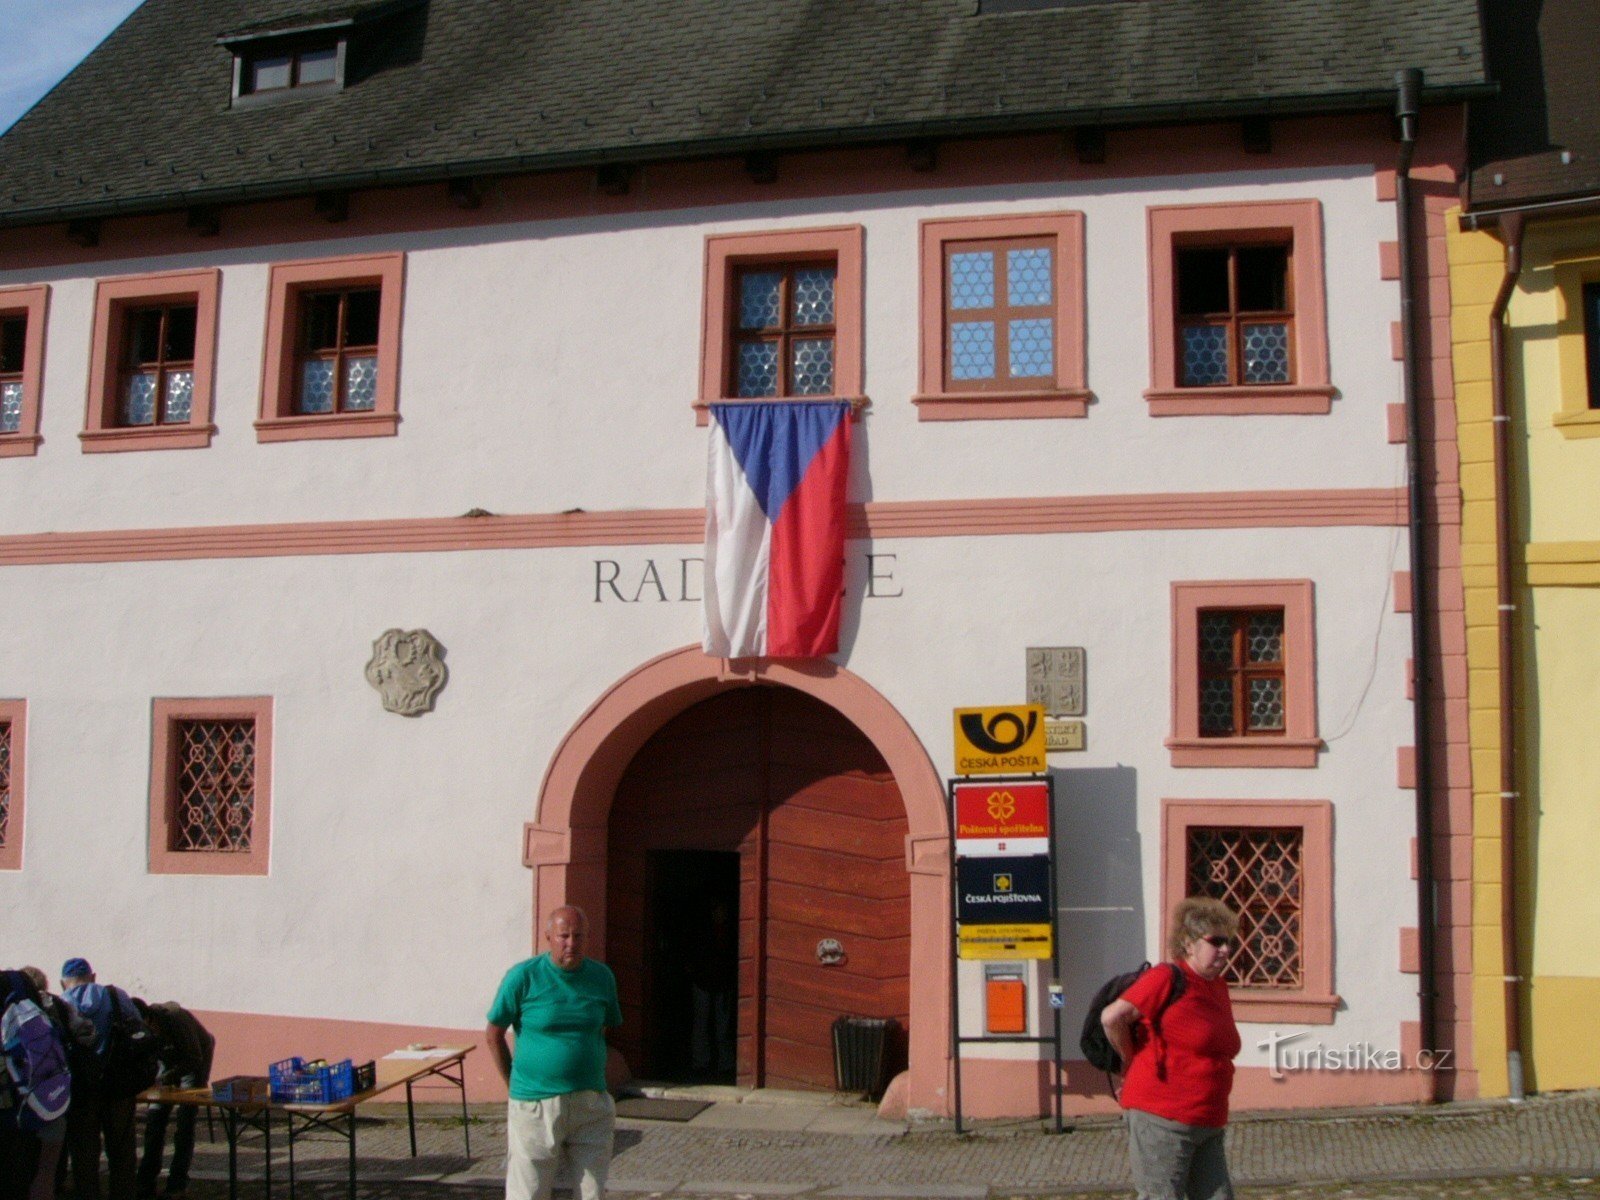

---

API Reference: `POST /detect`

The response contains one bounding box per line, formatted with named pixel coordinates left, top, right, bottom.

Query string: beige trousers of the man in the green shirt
left=506, top=1091, right=616, bottom=1200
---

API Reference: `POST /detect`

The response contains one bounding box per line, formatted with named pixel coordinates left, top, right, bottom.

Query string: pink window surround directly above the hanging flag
left=694, top=226, right=867, bottom=424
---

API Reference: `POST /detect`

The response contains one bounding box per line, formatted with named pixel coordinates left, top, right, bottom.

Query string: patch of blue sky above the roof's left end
left=0, top=0, right=139, bottom=130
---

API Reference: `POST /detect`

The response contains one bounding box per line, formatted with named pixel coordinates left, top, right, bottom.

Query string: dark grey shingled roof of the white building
left=0, top=0, right=1485, bottom=226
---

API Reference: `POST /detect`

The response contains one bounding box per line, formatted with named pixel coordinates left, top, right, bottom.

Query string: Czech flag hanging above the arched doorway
left=704, top=400, right=850, bottom=658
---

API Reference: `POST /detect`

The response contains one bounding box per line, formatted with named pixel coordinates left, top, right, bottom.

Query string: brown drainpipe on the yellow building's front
left=1490, top=213, right=1526, bottom=1101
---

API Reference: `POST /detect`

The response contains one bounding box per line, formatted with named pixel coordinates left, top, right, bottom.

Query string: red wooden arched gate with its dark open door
left=606, top=686, right=910, bottom=1090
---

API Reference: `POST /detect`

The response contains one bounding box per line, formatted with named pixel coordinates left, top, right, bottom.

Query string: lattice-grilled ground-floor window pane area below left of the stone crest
left=168, top=718, right=256, bottom=853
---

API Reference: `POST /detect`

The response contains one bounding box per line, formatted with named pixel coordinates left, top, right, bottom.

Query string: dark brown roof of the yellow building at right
left=1467, top=0, right=1600, bottom=210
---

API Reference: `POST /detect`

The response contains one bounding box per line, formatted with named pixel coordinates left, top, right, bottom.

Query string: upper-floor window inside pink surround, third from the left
left=294, top=286, right=381, bottom=414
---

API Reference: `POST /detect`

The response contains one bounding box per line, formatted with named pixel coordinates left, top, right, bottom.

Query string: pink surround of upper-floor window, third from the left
left=256, top=253, right=405, bottom=442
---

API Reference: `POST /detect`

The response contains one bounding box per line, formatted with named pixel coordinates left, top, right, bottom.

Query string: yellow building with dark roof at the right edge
left=1448, top=0, right=1600, bottom=1096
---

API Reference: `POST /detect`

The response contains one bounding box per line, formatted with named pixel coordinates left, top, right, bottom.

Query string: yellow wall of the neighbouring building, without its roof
left=1450, top=209, right=1600, bottom=1096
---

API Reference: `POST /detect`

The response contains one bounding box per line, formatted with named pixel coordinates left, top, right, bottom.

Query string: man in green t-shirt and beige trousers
left=483, top=906, right=622, bottom=1200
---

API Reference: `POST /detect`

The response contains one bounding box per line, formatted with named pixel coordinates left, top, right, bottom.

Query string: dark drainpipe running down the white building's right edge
left=1395, top=67, right=1438, bottom=1099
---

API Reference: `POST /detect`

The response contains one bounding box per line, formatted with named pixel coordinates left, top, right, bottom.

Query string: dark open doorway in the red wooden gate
left=646, top=850, right=739, bottom=1083
